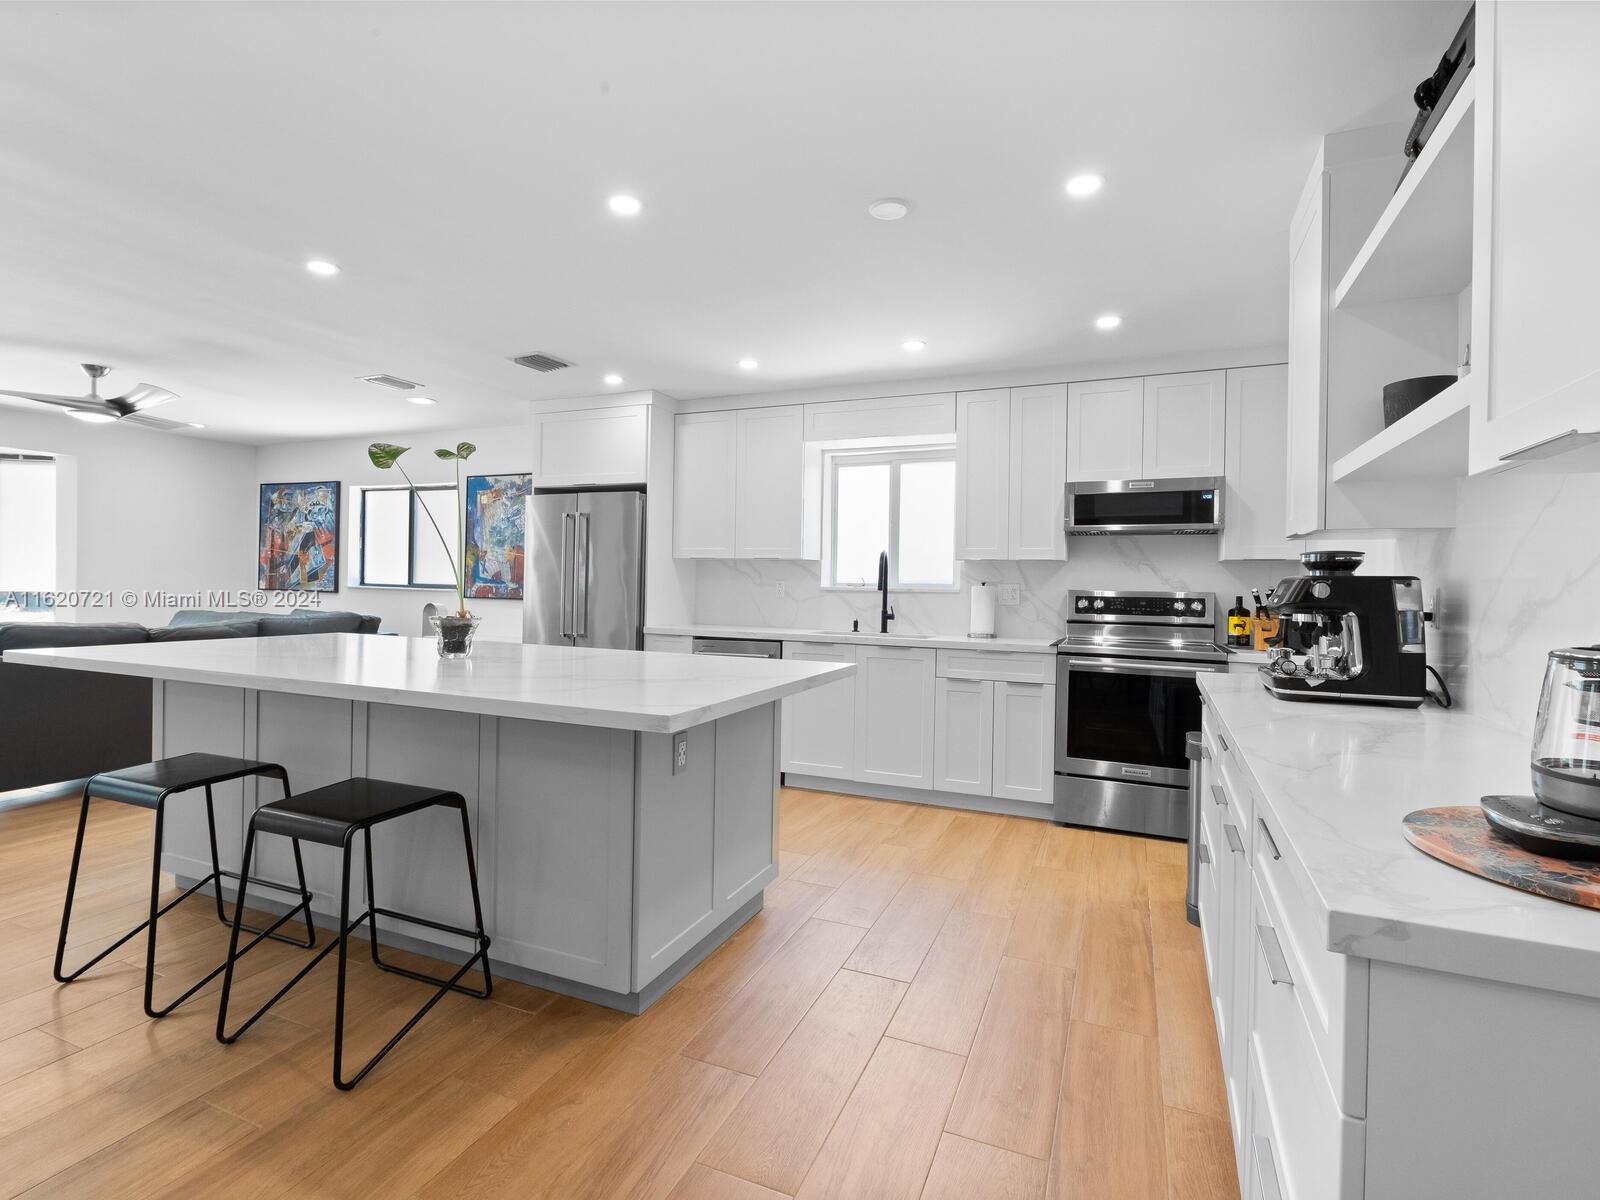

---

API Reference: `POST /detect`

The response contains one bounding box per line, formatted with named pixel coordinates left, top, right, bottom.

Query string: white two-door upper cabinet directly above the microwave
left=1067, top=371, right=1227, bottom=483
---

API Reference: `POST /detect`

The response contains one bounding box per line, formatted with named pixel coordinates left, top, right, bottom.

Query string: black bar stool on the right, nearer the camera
left=216, top=778, right=494, bottom=1091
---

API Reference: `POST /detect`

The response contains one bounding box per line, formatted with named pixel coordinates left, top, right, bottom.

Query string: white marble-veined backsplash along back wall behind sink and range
left=694, top=536, right=1299, bottom=638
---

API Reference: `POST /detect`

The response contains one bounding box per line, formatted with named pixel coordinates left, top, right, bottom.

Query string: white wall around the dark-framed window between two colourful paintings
left=252, top=419, right=533, bottom=642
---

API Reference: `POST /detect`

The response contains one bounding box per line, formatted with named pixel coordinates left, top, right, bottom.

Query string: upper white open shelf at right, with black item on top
left=1333, top=75, right=1477, bottom=309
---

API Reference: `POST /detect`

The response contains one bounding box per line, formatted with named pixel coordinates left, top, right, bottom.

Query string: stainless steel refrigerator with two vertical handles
left=522, top=491, right=645, bottom=650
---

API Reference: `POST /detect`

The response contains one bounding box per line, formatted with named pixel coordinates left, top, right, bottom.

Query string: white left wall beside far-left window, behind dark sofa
left=0, top=406, right=256, bottom=624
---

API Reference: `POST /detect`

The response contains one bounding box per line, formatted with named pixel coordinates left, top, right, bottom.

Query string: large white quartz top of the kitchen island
left=5, top=634, right=854, bottom=733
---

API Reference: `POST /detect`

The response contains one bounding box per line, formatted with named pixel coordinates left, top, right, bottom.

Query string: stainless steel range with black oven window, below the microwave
left=1056, top=592, right=1227, bottom=838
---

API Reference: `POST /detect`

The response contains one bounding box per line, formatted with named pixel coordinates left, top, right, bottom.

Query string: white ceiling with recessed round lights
left=0, top=0, right=1461, bottom=442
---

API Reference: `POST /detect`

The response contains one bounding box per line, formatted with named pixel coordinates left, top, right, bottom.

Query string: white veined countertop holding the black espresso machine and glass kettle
left=1200, top=674, right=1600, bottom=997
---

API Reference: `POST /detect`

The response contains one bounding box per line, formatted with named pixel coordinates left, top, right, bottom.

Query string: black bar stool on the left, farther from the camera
left=54, top=754, right=317, bottom=1018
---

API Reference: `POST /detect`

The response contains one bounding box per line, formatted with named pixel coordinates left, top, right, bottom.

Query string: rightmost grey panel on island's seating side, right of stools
left=478, top=717, right=634, bottom=995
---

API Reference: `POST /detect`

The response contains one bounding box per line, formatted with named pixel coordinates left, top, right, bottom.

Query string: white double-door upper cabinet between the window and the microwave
left=955, top=384, right=1067, bottom=562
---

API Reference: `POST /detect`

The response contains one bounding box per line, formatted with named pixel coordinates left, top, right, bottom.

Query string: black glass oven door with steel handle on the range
left=1056, top=654, right=1214, bottom=787
